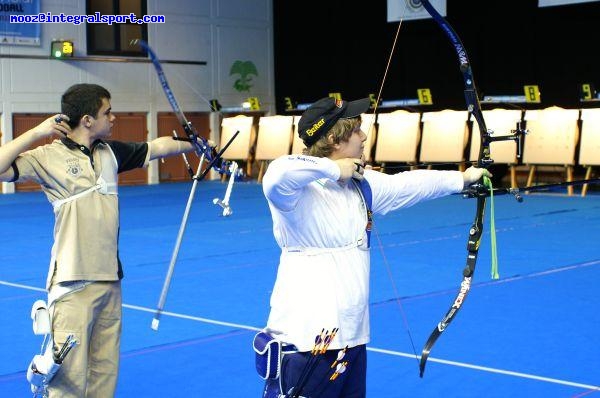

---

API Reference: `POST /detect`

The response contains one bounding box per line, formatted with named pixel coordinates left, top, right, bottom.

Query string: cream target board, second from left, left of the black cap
left=255, top=116, right=294, bottom=160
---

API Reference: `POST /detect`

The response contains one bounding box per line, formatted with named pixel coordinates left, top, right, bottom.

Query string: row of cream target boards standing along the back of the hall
left=221, top=107, right=600, bottom=195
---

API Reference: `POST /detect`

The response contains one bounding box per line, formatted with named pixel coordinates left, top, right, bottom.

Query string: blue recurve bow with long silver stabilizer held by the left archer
left=132, top=40, right=239, bottom=330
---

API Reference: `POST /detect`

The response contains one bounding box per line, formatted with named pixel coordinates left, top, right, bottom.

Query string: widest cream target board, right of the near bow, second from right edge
left=523, top=106, right=579, bottom=165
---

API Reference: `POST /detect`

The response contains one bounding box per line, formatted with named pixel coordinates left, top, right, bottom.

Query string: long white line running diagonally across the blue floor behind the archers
left=0, top=281, right=600, bottom=390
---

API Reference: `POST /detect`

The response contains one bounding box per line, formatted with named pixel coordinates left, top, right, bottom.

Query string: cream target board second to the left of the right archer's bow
left=375, top=110, right=421, bottom=163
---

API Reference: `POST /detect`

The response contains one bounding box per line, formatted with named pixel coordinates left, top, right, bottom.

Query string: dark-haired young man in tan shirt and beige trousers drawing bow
left=0, top=84, right=216, bottom=397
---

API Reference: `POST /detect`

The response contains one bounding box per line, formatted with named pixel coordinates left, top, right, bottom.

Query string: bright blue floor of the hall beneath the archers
left=0, top=182, right=600, bottom=398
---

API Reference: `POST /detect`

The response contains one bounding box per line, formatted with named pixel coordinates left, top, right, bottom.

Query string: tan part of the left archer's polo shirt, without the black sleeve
left=15, top=140, right=119, bottom=288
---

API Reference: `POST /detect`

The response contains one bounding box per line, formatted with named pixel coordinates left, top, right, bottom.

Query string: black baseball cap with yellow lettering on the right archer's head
left=298, top=97, right=371, bottom=147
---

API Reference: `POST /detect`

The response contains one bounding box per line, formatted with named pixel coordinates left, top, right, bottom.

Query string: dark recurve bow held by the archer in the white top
left=419, top=0, right=493, bottom=377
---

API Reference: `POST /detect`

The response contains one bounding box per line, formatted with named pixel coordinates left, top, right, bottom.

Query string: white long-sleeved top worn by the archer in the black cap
left=263, top=155, right=463, bottom=351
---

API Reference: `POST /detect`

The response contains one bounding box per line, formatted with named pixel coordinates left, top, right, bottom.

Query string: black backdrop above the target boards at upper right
left=273, top=0, right=600, bottom=113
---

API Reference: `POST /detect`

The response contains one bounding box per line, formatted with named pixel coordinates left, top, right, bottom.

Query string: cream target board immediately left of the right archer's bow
left=419, top=109, right=469, bottom=162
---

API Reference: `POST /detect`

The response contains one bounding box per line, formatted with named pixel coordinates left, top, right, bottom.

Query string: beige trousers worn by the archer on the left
left=48, top=281, right=121, bottom=398
